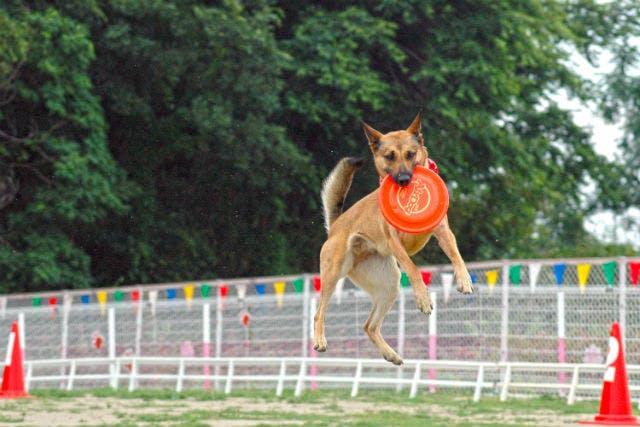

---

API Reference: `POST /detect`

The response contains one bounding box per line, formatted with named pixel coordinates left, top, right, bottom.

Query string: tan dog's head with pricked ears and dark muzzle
left=362, top=112, right=429, bottom=187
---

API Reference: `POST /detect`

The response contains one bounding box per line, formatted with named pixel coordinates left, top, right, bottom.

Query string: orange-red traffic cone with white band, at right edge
left=580, top=322, right=640, bottom=426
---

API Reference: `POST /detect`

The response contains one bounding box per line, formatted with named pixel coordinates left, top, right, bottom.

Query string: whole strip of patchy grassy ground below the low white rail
left=0, top=389, right=598, bottom=427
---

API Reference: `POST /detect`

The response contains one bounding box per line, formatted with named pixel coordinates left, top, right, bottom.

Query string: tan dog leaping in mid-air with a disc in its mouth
left=313, top=112, right=473, bottom=365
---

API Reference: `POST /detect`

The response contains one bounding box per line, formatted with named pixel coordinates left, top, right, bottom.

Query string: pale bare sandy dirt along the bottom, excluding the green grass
left=0, top=395, right=592, bottom=427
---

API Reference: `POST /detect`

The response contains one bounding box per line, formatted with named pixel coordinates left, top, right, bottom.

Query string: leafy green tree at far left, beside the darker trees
left=0, top=8, right=127, bottom=292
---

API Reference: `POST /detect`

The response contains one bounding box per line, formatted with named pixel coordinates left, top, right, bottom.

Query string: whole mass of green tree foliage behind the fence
left=0, top=0, right=638, bottom=290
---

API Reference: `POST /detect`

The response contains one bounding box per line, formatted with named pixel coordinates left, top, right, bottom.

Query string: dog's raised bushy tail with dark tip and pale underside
left=321, top=157, right=364, bottom=231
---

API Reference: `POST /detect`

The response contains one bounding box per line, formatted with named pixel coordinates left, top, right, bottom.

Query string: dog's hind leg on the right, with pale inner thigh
left=349, top=254, right=402, bottom=365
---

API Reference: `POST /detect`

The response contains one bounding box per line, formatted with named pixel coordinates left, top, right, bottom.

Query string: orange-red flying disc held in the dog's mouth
left=378, top=166, right=449, bottom=234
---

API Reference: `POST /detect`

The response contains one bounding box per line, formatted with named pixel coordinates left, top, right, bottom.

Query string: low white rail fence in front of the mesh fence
left=12, top=357, right=640, bottom=404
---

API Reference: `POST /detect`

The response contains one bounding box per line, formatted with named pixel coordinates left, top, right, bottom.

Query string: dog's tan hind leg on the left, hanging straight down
left=313, top=239, right=350, bottom=352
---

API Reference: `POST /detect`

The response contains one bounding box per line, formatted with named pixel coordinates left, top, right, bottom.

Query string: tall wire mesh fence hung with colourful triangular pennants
left=0, top=258, right=640, bottom=395
